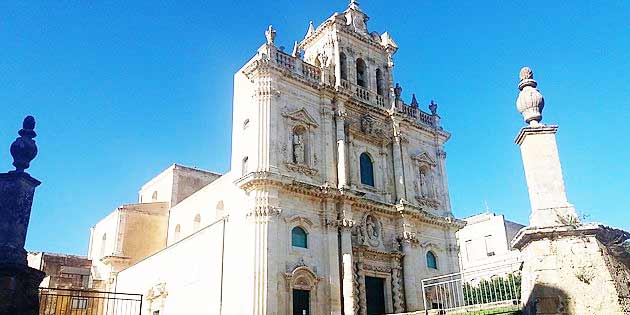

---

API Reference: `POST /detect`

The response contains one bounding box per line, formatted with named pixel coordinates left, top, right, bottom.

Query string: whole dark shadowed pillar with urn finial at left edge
left=0, top=116, right=45, bottom=315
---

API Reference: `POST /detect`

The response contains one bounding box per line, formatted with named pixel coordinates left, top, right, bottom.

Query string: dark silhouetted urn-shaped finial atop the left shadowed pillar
left=11, top=116, right=37, bottom=173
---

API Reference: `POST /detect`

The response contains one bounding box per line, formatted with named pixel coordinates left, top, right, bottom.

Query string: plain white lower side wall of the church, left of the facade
left=116, top=221, right=227, bottom=315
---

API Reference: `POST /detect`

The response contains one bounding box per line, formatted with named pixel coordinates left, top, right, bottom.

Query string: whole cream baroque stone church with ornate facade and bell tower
left=89, top=1, right=464, bottom=315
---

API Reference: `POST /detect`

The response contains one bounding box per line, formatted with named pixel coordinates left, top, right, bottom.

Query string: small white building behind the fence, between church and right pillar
left=457, top=212, right=525, bottom=272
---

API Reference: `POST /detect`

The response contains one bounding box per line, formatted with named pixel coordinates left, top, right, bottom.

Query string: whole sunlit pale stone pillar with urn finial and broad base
left=511, top=67, right=630, bottom=315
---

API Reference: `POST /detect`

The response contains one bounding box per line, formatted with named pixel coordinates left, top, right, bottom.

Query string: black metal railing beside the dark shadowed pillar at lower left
left=39, top=288, right=142, bottom=315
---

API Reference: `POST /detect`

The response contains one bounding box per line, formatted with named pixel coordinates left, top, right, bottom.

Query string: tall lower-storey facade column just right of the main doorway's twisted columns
left=400, top=233, right=420, bottom=312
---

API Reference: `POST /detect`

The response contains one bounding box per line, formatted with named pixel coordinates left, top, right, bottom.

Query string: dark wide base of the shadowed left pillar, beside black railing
left=0, top=264, right=46, bottom=315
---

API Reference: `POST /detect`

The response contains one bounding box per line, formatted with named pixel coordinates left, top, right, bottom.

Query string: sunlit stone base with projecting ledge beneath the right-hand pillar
left=512, top=224, right=630, bottom=314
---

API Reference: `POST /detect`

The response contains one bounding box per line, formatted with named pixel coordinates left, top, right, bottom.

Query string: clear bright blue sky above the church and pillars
left=0, top=0, right=630, bottom=254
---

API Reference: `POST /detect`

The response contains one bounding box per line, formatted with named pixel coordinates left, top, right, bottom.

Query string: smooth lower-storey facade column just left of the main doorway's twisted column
left=339, top=219, right=357, bottom=315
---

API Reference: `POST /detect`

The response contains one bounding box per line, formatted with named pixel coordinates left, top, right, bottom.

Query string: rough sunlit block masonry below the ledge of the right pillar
left=522, top=233, right=630, bottom=314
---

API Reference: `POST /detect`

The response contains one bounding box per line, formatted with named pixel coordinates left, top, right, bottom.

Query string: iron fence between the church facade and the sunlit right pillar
left=422, top=261, right=521, bottom=314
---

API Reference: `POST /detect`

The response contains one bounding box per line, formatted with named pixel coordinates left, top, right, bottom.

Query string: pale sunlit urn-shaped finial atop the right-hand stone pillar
left=516, top=67, right=545, bottom=126
